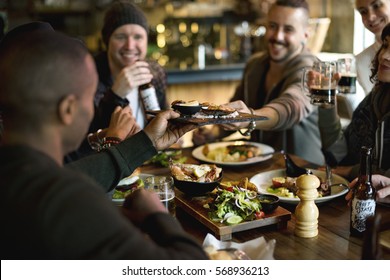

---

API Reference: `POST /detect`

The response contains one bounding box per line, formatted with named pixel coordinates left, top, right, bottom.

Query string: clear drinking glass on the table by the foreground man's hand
left=144, top=176, right=176, bottom=216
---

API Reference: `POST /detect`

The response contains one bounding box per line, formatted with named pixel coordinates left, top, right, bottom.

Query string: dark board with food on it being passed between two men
left=146, top=100, right=268, bottom=126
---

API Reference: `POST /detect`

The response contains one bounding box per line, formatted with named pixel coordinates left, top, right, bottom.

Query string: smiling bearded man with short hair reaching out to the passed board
left=193, top=0, right=324, bottom=164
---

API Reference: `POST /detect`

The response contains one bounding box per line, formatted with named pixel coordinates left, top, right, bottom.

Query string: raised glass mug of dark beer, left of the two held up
left=302, top=61, right=337, bottom=108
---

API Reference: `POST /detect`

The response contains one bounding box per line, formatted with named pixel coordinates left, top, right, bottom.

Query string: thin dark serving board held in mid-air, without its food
left=146, top=111, right=268, bottom=126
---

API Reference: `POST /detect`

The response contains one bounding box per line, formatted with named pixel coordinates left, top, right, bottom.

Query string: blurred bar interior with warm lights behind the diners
left=0, top=0, right=374, bottom=144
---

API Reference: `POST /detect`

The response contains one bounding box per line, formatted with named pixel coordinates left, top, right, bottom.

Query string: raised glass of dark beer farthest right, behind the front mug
left=337, top=57, right=357, bottom=94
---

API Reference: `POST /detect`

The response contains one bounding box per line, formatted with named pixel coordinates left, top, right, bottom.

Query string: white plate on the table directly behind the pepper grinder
left=250, top=169, right=349, bottom=204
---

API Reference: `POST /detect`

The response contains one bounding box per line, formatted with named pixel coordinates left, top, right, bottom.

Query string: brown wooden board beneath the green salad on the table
left=175, top=189, right=291, bottom=241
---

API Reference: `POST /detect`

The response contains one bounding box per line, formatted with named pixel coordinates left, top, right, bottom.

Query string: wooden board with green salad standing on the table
left=170, top=165, right=291, bottom=240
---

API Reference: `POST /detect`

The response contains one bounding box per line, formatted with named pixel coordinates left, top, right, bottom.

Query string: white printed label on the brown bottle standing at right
left=351, top=198, right=376, bottom=232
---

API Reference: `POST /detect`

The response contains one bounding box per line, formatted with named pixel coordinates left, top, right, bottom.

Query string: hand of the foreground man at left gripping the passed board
left=144, top=110, right=196, bottom=151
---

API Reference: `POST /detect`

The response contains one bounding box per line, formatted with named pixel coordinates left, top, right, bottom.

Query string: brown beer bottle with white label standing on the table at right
left=350, top=146, right=375, bottom=236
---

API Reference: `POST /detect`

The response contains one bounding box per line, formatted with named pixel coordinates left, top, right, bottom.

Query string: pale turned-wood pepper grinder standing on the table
left=295, top=174, right=321, bottom=238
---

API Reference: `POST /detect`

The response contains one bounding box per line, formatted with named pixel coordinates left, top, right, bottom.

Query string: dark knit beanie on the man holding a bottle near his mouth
left=102, top=1, right=149, bottom=46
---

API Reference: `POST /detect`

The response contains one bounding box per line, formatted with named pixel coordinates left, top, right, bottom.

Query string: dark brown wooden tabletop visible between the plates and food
left=142, top=149, right=390, bottom=260
